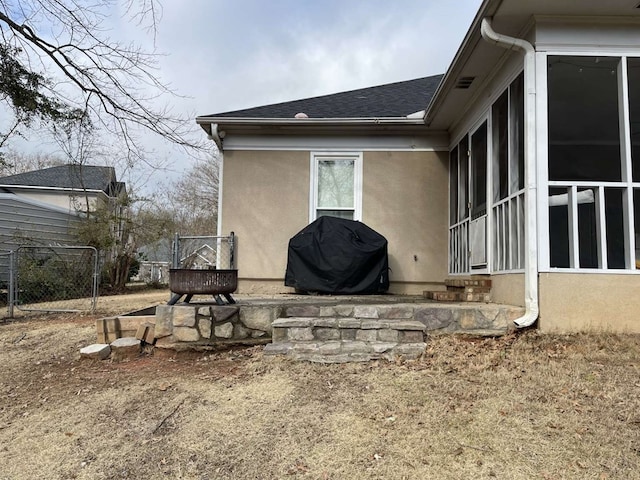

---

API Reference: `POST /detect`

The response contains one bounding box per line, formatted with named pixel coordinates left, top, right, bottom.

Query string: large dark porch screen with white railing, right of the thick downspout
left=547, top=56, right=640, bottom=270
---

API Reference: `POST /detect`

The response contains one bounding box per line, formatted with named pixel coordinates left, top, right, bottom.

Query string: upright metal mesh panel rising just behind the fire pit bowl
left=172, top=232, right=235, bottom=270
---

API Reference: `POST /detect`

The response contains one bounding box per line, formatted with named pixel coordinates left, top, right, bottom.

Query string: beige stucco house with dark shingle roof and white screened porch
left=197, top=0, right=640, bottom=332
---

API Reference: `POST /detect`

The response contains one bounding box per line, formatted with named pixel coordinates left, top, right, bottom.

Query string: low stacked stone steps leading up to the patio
left=264, top=317, right=426, bottom=363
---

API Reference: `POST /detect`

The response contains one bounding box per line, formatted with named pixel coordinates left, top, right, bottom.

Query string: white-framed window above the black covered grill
left=309, top=152, right=362, bottom=221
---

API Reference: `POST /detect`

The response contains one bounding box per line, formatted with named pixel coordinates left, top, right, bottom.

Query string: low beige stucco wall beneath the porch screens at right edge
left=539, top=273, right=640, bottom=333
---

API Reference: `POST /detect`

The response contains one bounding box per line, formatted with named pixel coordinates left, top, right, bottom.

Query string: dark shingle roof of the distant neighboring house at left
left=0, top=165, right=122, bottom=194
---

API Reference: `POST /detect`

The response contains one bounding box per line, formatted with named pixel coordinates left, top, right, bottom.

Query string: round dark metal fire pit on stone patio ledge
left=169, top=268, right=238, bottom=305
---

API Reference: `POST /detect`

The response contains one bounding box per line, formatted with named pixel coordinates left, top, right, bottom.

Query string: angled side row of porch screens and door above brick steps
left=449, top=74, right=525, bottom=273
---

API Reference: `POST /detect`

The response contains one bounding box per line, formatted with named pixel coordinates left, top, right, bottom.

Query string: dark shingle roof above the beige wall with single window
left=206, top=75, right=443, bottom=118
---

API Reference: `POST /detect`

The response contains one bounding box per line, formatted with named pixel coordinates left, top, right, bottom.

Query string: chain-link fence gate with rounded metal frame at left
left=7, top=246, right=99, bottom=313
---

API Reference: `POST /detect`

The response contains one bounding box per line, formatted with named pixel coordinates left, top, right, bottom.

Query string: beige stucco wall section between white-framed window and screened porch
left=362, top=152, right=448, bottom=294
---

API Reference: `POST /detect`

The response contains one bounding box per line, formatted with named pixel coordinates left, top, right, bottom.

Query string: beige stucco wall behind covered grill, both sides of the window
left=221, top=151, right=447, bottom=294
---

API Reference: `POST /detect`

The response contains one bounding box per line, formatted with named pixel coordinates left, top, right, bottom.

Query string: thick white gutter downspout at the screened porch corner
left=480, top=17, right=540, bottom=328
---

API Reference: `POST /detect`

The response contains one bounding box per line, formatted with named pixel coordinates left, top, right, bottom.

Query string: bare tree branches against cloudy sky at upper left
left=0, top=0, right=203, bottom=164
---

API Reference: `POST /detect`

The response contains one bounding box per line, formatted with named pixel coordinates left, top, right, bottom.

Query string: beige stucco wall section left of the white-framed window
left=222, top=151, right=309, bottom=293
